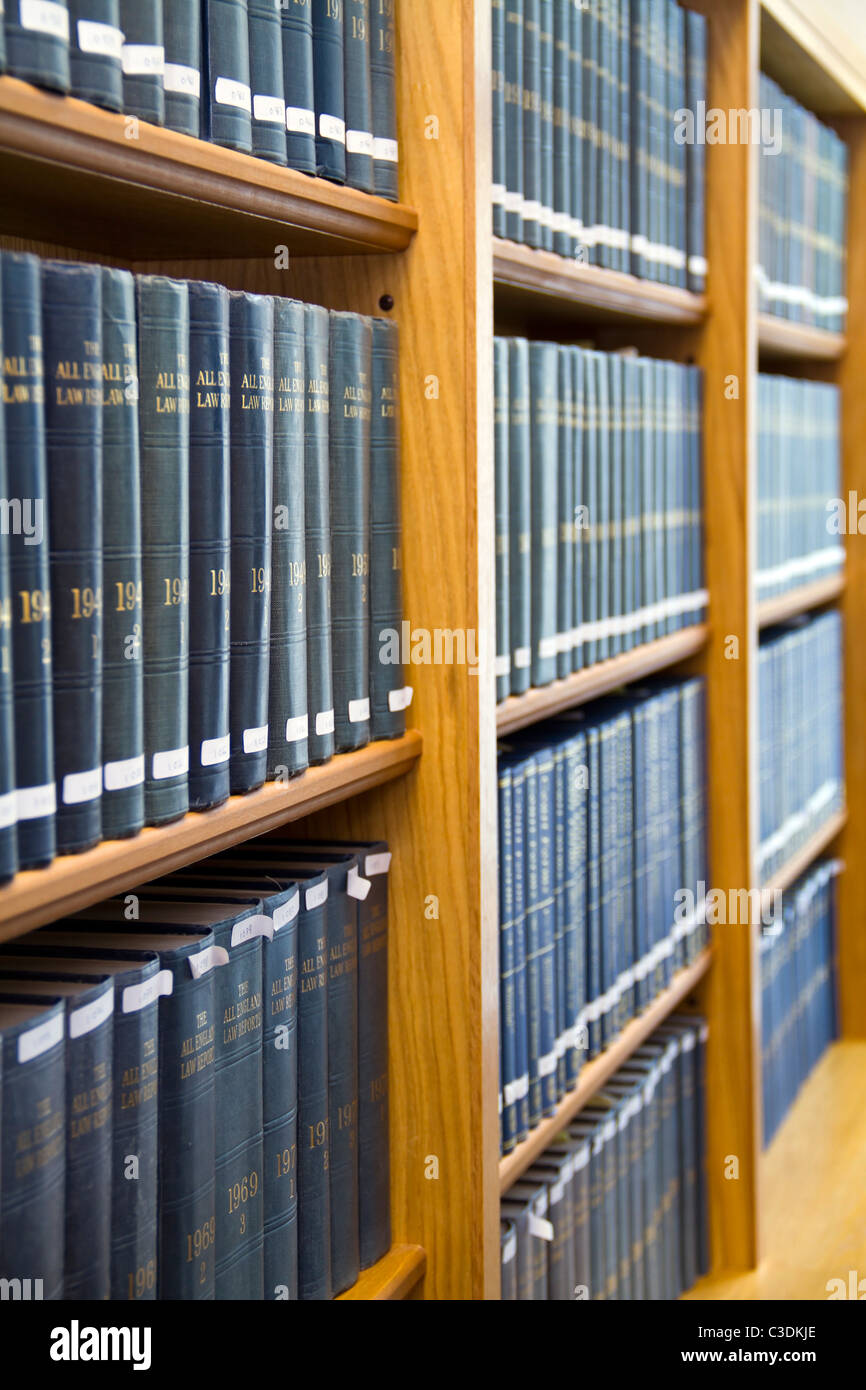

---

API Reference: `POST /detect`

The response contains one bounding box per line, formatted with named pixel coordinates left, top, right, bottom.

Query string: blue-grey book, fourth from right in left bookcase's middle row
left=268, top=299, right=309, bottom=778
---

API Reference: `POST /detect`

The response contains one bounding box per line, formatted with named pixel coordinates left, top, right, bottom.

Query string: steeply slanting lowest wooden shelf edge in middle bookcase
left=499, top=947, right=713, bottom=1194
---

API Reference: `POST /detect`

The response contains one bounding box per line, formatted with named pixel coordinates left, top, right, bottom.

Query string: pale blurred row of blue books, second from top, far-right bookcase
left=756, top=375, right=845, bottom=599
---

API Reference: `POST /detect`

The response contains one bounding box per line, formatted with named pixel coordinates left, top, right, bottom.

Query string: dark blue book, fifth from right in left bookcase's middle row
left=229, top=291, right=274, bottom=792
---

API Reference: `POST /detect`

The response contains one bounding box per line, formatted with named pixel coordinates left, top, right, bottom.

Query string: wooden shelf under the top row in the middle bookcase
left=493, top=238, right=706, bottom=325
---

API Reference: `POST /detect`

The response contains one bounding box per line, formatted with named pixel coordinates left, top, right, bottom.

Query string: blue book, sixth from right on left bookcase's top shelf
left=203, top=0, right=253, bottom=154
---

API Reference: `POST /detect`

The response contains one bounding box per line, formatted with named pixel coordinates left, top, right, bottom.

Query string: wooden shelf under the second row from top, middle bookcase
left=496, top=624, right=709, bottom=737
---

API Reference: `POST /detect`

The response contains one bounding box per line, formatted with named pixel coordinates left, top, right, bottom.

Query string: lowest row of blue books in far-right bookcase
left=759, top=859, right=842, bottom=1144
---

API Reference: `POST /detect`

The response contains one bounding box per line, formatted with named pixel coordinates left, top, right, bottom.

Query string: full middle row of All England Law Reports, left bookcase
left=0, top=253, right=409, bottom=877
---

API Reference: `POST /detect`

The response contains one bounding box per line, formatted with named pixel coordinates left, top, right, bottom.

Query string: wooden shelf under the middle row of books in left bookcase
left=0, top=730, right=421, bottom=941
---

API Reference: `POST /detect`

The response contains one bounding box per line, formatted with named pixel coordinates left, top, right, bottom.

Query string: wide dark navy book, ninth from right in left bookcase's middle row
left=42, top=261, right=103, bottom=853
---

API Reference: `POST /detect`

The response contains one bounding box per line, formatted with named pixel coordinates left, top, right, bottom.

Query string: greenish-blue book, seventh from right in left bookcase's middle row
left=136, top=275, right=189, bottom=826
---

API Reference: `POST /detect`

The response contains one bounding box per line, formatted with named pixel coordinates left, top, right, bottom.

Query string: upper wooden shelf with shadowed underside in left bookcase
left=0, top=76, right=418, bottom=261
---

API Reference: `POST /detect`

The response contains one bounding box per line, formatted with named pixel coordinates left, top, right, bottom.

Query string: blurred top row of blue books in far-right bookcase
left=756, top=72, right=848, bottom=332
